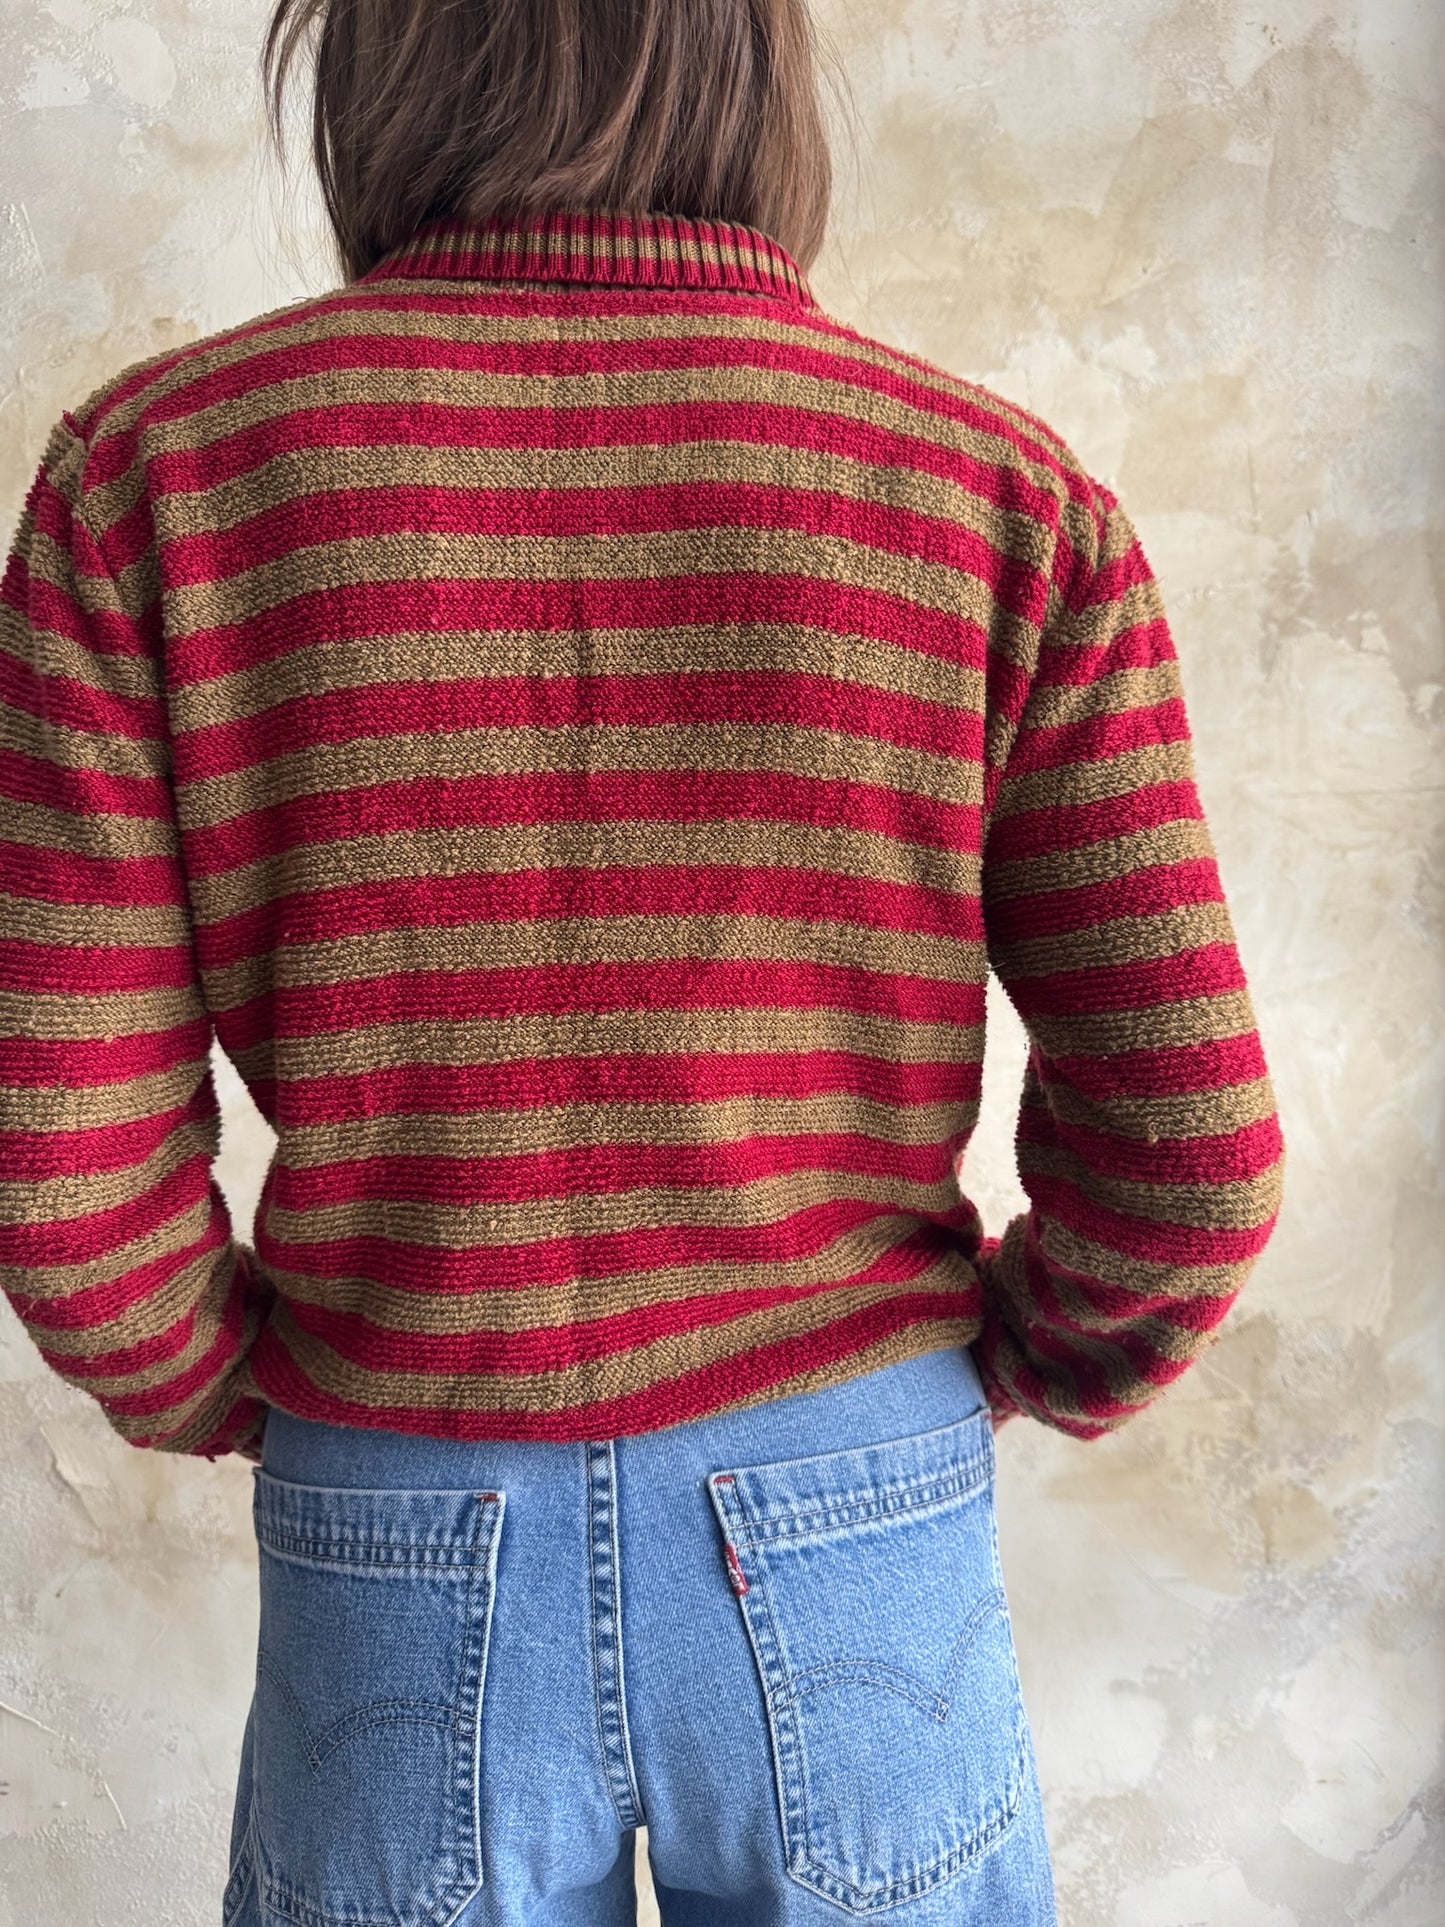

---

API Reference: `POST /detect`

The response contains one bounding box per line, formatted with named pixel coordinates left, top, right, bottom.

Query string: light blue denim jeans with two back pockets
left=222, top=1347, right=1056, bottom=1927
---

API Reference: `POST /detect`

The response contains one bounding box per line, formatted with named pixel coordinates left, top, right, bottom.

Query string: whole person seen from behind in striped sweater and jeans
left=0, top=0, right=1283, bottom=1927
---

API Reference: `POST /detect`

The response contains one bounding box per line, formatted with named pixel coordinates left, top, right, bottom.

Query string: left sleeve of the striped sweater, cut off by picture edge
left=0, top=414, right=272, bottom=1461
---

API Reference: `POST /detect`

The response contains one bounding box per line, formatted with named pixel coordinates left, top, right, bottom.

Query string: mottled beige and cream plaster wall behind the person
left=0, top=0, right=1445, bottom=1927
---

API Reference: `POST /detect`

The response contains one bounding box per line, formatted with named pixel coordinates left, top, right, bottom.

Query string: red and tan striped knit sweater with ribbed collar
left=0, top=212, right=1283, bottom=1461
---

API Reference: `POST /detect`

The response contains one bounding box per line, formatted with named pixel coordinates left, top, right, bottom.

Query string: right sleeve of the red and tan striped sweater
left=975, top=484, right=1285, bottom=1439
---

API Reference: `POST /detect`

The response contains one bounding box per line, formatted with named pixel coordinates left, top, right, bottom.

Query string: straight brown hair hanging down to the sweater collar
left=262, top=0, right=846, bottom=279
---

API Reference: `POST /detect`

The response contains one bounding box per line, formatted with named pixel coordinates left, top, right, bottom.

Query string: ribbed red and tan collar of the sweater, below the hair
left=360, top=208, right=817, bottom=308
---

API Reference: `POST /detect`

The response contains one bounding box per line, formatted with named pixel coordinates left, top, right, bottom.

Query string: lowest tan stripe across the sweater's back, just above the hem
left=262, top=1278, right=977, bottom=1412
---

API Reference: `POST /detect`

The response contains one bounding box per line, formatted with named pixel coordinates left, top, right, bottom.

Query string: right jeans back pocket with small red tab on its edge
left=707, top=1411, right=1029, bottom=1914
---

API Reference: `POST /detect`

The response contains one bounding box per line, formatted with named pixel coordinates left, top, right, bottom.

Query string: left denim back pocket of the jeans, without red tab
left=250, top=1466, right=505, bottom=1927
